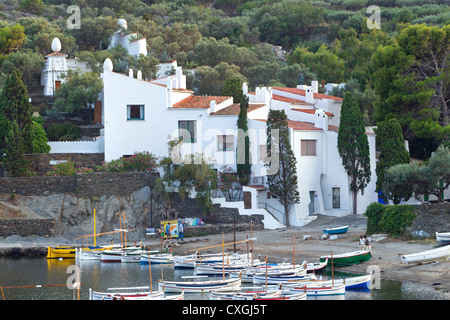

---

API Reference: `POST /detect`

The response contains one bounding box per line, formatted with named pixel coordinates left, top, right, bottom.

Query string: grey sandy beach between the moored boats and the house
left=0, top=215, right=450, bottom=299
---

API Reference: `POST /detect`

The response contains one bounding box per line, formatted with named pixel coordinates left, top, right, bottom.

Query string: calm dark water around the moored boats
left=0, top=257, right=442, bottom=300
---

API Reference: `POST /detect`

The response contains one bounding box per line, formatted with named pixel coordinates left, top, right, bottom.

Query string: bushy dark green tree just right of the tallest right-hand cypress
left=375, top=119, right=409, bottom=200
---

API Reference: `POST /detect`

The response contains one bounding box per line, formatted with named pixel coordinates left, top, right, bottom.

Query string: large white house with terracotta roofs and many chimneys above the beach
left=102, top=59, right=377, bottom=226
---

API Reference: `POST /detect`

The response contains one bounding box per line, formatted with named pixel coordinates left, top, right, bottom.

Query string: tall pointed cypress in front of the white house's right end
left=338, top=91, right=371, bottom=214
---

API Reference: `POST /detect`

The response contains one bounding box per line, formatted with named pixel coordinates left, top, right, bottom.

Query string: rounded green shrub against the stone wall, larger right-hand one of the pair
left=379, top=205, right=416, bottom=236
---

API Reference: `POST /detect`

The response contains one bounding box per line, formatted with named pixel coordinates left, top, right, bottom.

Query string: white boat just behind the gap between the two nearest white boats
left=158, top=279, right=241, bottom=293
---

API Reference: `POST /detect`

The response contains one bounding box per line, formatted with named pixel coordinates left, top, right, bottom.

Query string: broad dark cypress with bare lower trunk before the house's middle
left=266, top=110, right=300, bottom=226
